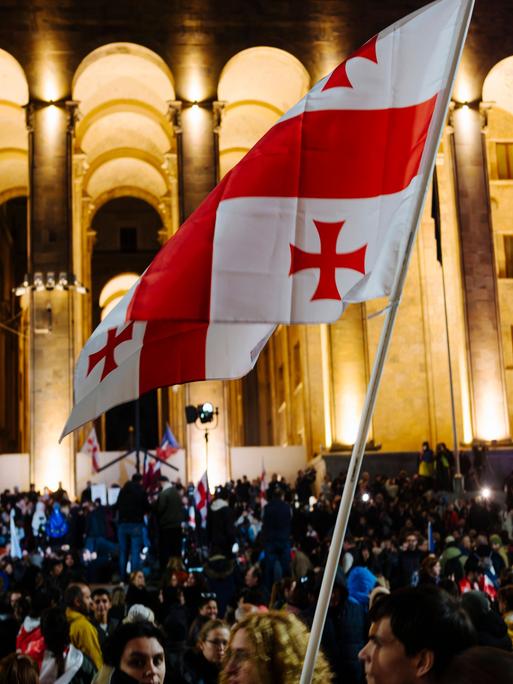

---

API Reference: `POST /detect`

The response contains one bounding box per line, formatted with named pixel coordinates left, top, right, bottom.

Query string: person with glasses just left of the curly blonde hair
left=181, top=620, right=230, bottom=684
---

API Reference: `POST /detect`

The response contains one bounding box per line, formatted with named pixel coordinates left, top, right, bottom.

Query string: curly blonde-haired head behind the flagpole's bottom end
left=219, top=610, right=332, bottom=684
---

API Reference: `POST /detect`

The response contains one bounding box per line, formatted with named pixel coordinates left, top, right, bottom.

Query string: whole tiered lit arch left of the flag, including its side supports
left=72, top=43, right=179, bottom=358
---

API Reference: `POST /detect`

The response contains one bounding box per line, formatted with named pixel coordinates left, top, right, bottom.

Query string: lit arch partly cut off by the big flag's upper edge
left=218, top=46, right=310, bottom=176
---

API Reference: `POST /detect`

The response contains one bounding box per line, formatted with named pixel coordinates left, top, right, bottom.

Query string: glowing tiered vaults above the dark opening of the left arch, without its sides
left=72, top=43, right=176, bottom=211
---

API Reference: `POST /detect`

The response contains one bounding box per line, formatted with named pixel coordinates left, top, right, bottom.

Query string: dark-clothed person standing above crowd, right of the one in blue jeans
left=155, top=475, right=184, bottom=570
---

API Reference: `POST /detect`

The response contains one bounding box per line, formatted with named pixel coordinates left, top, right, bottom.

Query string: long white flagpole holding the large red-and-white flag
left=300, top=0, right=475, bottom=684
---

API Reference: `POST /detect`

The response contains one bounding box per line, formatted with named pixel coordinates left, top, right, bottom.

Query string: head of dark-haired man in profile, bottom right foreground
left=360, top=585, right=477, bottom=684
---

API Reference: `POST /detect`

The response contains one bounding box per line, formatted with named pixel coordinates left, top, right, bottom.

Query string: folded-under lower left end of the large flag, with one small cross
left=61, top=283, right=274, bottom=439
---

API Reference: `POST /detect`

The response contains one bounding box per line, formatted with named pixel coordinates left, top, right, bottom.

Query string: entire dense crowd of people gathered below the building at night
left=0, top=456, right=513, bottom=684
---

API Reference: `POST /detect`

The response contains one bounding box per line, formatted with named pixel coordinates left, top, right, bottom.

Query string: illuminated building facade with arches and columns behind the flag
left=0, top=0, right=513, bottom=490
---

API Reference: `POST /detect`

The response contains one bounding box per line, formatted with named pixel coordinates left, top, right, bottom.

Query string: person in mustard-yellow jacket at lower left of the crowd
left=64, top=584, right=102, bottom=669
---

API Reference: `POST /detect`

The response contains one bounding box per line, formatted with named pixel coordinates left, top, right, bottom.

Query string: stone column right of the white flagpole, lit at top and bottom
left=452, top=106, right=510, bottom=441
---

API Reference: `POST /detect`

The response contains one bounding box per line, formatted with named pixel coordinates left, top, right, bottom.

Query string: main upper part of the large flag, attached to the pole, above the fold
left=128, top=0, right=468, bottom=323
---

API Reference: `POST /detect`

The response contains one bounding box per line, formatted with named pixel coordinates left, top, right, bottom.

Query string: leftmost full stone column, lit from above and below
left=28, top=103, right=75, bottom=495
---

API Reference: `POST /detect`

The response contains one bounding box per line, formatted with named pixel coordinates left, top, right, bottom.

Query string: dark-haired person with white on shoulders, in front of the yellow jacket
left=39, top=608, right=96, bottom=684
